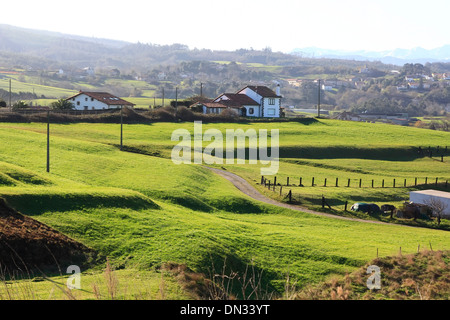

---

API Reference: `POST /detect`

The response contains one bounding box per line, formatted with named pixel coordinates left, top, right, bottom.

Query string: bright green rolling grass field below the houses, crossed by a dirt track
left=0, top=120, right=450, bottom=298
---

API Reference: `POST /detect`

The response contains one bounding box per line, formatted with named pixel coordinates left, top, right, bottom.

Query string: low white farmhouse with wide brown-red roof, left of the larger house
left=66, top=91, right=134, bottom=110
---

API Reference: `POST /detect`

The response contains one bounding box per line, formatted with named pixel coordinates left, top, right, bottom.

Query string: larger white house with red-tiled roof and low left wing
left=193, top=85, right=281, bottom=118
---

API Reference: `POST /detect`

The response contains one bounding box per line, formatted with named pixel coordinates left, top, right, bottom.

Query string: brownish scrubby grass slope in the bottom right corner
left=293, top=250, right=450, bottom=300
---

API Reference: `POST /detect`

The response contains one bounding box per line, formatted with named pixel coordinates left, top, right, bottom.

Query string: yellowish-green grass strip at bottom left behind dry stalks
left=0, top=269, right=188, bottom=300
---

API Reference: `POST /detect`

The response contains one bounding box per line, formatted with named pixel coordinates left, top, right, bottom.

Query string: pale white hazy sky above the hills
left=0, top=0, right=450, bottom=52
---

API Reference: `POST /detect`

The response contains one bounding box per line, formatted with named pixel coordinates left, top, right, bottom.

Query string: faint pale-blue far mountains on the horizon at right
left=291, top=45, right=450, bottom=65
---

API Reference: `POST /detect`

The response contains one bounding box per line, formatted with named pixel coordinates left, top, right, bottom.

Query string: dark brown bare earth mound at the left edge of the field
left=0, top=199, right=96, bottom=277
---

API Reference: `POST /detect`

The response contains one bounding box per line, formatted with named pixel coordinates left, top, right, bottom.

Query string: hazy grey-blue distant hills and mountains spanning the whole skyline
left=0, top=24, right=450, bottom=68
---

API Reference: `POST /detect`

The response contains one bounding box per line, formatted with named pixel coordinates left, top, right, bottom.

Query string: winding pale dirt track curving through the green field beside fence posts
left=203, top=166, right=404, bottom=227
